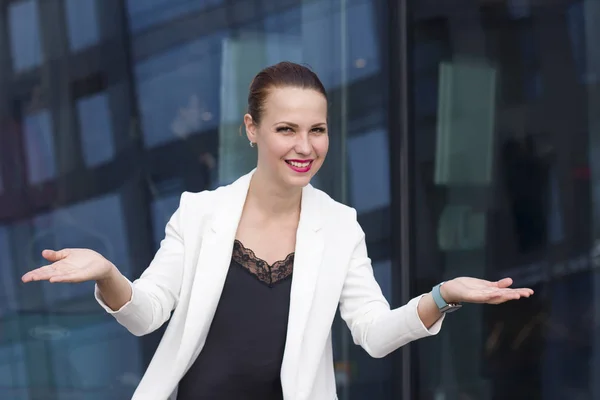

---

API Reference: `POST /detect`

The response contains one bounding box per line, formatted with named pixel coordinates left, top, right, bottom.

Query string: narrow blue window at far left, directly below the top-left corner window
left=24, top=110, right=56, bottom=184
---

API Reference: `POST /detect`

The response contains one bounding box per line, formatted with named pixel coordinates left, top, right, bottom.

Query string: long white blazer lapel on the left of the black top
left=173, top=170, right=254, bottom=369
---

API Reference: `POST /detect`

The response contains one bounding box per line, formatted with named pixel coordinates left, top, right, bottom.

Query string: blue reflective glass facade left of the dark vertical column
left=0, top=0, right=392, bottom=400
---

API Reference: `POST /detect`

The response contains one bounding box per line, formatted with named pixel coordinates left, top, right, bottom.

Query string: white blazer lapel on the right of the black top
left=281, top=185, right=324, bottom=399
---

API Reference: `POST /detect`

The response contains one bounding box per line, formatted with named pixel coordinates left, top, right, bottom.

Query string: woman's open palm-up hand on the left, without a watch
left=21, top=249, right=116, bottom=283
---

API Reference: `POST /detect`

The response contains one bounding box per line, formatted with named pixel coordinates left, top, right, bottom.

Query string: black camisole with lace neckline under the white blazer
left=177, top=240, right=294, bottom=400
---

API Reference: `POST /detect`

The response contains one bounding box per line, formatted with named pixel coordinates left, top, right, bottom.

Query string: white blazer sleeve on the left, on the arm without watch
left=94, top=193, right=186, bottom=336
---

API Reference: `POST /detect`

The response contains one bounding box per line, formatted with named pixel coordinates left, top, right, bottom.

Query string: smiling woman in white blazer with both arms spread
left=23, top=63, right=533, bottom=400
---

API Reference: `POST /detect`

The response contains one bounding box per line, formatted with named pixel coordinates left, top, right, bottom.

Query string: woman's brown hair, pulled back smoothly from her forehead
left=248, top=61, right=327, bottom=125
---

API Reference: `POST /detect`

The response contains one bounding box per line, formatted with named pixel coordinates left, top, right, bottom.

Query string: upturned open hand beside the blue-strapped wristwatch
left=440, top=277, right=533, bottom=304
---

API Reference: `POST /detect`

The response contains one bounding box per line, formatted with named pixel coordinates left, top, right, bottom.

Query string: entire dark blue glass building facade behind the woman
left=0, top=0, right=600, bottom=400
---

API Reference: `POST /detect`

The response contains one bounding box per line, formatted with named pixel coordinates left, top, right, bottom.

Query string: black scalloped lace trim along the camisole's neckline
left=232, top=239, right=294, bottom=286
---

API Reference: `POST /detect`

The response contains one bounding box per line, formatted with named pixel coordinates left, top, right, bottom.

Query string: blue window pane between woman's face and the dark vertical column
left=348, top=130, right=390, bottom=213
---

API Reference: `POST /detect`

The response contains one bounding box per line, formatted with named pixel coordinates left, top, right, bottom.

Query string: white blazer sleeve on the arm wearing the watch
left=340, top=222, right=444, bottom=358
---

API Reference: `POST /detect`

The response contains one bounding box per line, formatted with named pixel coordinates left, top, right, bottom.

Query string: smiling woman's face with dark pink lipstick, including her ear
left=244, top=87, right=329, bottom=187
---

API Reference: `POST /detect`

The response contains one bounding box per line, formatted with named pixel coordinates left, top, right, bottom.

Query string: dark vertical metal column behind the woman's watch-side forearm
left=388, top=0, right=417, bottom=400
